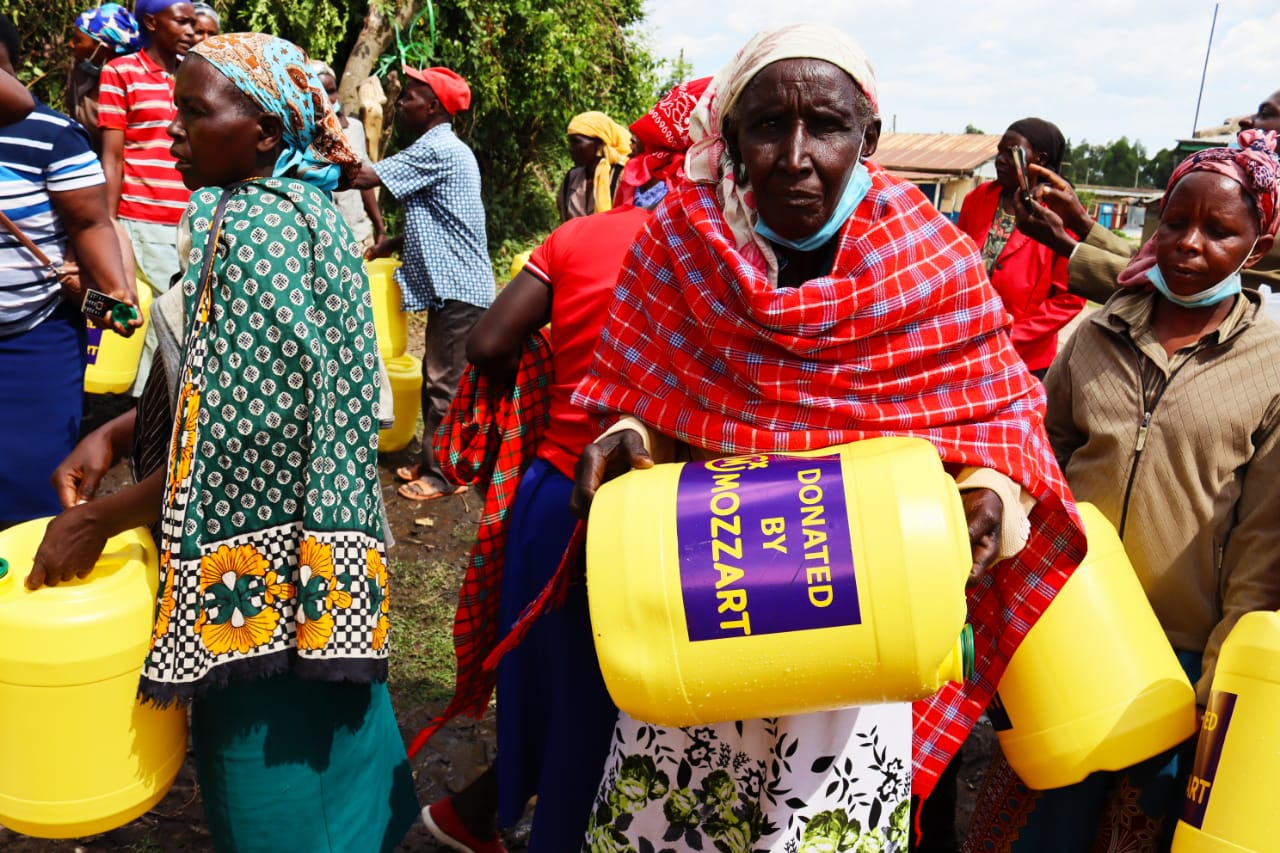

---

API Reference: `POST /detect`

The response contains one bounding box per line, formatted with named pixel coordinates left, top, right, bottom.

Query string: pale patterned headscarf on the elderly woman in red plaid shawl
left=685, top=24, right=879, bottom=266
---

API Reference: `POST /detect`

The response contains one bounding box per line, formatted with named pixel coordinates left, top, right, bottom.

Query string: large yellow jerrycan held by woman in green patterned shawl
left=0, top=519, right=187, bottom=838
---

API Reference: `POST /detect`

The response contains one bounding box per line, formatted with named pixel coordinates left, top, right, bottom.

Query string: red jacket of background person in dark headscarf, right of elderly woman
left=956, top=181, right=1084, bottom=370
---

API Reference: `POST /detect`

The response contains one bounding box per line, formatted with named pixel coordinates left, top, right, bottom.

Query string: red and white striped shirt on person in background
left=97, top=50, right=191, bottom=225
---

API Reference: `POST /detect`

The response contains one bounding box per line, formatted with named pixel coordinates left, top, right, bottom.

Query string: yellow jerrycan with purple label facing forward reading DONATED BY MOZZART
left=586, top=438, right=973, bottom=726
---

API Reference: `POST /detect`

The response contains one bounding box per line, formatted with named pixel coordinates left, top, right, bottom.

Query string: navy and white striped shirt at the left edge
left=0, top=102, right=105, bottom=337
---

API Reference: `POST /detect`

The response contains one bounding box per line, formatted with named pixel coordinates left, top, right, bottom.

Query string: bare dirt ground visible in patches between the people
left=0, top=308, right=995, bottom=853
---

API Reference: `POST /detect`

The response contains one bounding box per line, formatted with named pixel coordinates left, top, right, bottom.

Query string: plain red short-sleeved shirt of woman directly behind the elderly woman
left=525, top=205, right=650, bottom=479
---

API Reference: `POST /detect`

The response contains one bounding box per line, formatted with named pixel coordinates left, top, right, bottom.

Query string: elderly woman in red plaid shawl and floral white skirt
left=573, top=24, right=1084, bottom=850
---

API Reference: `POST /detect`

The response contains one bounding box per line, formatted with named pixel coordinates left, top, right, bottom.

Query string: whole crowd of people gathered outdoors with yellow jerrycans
left=0, top=6, right=1280, bottom=853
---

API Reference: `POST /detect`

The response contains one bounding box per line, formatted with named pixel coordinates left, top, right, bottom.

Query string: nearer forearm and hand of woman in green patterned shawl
left=27, top=469, right=165, bottom=589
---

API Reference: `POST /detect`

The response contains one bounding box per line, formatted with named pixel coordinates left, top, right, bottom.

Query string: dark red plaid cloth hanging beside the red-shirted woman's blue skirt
left=408, top=332, right=552, bottom=756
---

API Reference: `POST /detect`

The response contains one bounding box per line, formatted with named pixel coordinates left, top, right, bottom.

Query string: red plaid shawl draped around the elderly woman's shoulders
left=573, top=164, right=1084, bottom=797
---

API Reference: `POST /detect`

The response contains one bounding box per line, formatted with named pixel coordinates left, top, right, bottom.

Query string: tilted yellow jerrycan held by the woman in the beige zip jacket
left=988, top=503, right=1196, bottom=790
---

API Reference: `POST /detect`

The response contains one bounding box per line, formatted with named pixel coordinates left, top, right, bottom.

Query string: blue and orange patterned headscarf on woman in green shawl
left=191, top=32, right=360, bottom=191
